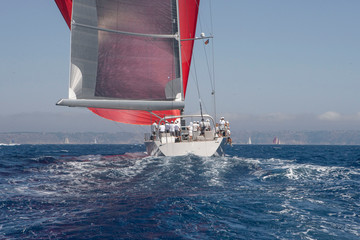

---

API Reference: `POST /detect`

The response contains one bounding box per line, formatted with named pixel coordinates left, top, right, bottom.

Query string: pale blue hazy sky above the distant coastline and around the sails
left=0, top=0, right=360, bottom=132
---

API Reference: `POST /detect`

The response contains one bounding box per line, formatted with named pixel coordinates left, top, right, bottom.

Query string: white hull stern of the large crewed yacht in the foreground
left=145, top=137, right=226, bottom=157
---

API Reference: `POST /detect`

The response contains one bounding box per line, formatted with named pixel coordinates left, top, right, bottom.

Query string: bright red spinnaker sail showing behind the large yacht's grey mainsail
left=55, top=0, right=200, bottom=125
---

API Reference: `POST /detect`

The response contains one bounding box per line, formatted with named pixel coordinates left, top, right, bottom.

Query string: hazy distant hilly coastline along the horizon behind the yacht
left=0, top=130, right=360, bottom=145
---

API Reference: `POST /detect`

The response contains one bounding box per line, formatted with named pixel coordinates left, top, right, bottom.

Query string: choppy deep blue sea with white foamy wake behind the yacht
left=0, top=145, right=360, bottom=239
